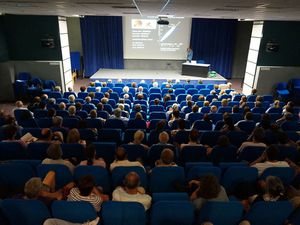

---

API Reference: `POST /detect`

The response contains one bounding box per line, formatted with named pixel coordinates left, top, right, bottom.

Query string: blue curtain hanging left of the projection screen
left=80, top=16, right=124, bottom=77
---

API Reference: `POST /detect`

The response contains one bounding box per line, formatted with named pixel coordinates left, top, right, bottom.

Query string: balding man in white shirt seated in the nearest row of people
left=112, top=172, right=151, bottom=211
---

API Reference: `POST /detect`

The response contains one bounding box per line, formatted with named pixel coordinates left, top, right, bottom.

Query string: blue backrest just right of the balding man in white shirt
left=150, top=166, right=185, bottom=193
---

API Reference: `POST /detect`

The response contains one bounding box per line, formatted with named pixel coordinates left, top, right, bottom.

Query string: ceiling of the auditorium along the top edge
left=0, top=0, right=300, bottom=20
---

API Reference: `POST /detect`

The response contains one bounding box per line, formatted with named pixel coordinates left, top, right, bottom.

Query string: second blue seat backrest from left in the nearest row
left=51, top=200, right=97, bottom=223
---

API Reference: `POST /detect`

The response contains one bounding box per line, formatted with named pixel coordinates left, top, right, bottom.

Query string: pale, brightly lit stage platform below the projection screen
left=90, top=69, right=227, bottom=84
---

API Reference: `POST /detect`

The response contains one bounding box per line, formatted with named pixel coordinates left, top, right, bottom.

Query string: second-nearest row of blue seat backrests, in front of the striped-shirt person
left=0, top=160, right=295, bottom=194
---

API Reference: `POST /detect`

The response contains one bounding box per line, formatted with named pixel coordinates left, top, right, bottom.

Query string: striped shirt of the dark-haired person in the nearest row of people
left=68, top=187, right=102, bottom=212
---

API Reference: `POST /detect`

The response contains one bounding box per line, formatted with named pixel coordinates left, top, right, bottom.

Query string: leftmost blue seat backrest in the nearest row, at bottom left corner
left=1, top=199, right=51, bottom=225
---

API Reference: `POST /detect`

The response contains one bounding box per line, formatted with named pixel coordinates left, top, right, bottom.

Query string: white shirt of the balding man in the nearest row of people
left=112, top=187, right=151, bottom=210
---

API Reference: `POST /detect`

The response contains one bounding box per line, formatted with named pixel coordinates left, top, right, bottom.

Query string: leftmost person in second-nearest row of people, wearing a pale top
left=42, top=143, right=75, bottom=173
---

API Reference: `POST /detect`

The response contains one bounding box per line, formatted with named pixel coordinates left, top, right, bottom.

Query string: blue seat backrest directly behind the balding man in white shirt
left=101, top=201, right=146, bottom=225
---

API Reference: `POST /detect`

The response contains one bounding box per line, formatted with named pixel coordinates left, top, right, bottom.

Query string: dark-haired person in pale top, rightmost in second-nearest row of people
left=250, top=145, right=289, bottom=176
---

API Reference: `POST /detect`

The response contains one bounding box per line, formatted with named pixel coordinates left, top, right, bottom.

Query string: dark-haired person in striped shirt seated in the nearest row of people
left=68, top=175, right=107, bottom=212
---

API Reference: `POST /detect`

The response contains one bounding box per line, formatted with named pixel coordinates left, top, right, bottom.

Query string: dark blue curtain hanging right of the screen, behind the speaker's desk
left=190, top=18, right=237, bottom=78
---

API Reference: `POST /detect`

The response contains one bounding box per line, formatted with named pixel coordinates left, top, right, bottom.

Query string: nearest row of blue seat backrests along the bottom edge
left=0, top=197, right=300, bottom=225
